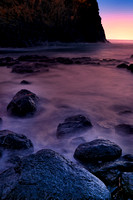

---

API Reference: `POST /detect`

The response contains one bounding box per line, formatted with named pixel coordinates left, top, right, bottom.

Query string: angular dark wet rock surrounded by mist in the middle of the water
left=56, top=115, right=92, bottom=138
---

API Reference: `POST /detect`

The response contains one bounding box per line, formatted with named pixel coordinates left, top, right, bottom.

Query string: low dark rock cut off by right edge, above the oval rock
left=115, top=124, right=133, bottom=135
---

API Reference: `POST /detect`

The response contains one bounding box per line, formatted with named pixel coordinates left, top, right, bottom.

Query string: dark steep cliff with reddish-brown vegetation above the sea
left=0, top=0, right=106, bottom=47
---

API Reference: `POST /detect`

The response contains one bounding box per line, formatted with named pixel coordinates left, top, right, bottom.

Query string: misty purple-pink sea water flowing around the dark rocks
left=0, top=42, right=133, bottom=160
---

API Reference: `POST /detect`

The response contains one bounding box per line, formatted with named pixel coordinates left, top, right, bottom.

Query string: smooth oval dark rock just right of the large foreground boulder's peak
left=74, top=139, right=122, bottom=163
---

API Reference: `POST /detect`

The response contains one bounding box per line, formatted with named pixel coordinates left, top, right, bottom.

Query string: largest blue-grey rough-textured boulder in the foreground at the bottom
left=0, top=150, right=110, bottom=200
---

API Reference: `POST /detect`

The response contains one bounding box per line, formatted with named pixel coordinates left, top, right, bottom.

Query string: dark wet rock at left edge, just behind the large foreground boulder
left=0, top=130, right=34, bottom=155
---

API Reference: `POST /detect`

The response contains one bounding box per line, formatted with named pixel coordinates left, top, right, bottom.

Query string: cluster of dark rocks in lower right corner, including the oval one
left=74, top=139, right=133, bottom=200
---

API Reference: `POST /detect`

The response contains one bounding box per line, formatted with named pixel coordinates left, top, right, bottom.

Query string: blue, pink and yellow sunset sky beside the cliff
left=97, top=0, right=133, bottom=40
